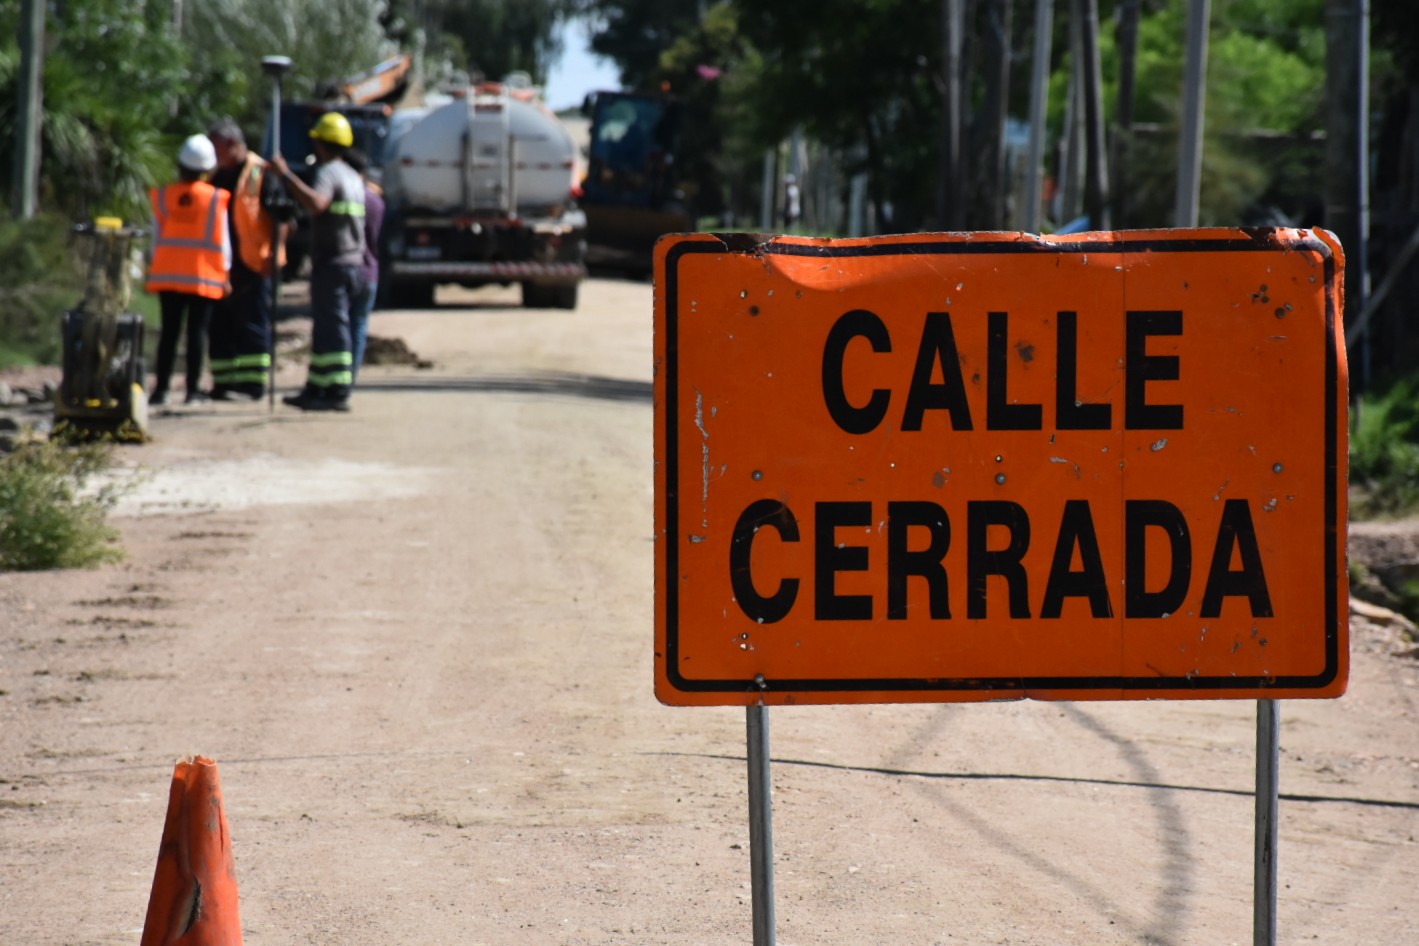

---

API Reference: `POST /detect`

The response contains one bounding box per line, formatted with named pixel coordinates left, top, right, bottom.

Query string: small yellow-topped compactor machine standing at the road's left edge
left=54, top=217, right=148, bottom=443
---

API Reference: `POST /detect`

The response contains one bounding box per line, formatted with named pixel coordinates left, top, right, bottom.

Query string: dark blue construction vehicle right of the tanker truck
left=580, top=92, right=695, bottom=272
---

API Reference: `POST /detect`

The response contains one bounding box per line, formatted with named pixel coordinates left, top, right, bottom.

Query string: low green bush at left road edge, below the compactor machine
left=0, top=443, right=122, bottom=572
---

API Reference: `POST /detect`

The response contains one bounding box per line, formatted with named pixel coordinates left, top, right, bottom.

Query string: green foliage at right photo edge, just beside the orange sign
left=1349, top=376, right=1419, bottom=518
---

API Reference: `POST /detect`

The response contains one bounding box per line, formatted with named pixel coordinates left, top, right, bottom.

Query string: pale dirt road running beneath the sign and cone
left=0, top=281, right=1419, bottom=946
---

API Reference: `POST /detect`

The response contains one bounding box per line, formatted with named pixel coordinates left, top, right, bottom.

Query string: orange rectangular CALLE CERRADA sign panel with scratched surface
left=656, top=230, right=1348, bottom=705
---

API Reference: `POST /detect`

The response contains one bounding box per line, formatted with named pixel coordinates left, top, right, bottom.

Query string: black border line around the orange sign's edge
left=663, top=230, right=1341, bottom=699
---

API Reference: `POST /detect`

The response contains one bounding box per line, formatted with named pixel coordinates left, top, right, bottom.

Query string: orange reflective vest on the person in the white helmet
left=148, top=180, right=230, bottom=299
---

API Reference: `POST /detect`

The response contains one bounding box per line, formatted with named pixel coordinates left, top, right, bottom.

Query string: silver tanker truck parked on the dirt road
left=379, top=77, right=586, bottom=309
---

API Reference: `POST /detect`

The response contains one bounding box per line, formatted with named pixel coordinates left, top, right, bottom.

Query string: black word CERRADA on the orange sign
left=729, top=499, right=1273, bottom=624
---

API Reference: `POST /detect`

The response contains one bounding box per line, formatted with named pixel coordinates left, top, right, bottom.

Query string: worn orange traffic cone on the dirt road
left=140, top=756, right=241, bottom=946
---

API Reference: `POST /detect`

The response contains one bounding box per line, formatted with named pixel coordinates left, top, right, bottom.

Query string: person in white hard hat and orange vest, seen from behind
left=148, top=135, right=231, bottom=404
